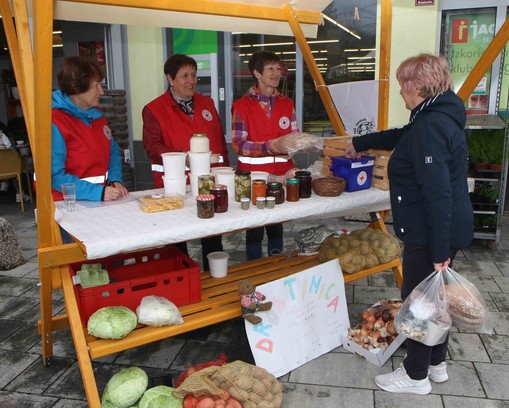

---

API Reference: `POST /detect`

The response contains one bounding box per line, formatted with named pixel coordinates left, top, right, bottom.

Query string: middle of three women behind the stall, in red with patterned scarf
left=142, top=54, right=230, bottom=270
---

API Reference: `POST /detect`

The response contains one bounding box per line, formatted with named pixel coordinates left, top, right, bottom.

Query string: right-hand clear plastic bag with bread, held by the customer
left=442, top=268, right=493, bottom=334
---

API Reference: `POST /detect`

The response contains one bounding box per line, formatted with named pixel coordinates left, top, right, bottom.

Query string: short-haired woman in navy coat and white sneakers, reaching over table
left=346, top=54, right=473, bottom=394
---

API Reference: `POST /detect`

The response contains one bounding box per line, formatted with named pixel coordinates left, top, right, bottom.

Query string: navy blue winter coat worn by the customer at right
left=353, top=91, right=474, bottom=263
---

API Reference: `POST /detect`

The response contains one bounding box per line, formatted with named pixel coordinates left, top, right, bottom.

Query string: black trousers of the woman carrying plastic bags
left=401, top=244, right=457, bottom=380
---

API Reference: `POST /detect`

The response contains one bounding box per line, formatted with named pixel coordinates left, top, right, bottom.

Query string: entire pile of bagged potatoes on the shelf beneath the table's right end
left=318, top=228, right=401, bottom=273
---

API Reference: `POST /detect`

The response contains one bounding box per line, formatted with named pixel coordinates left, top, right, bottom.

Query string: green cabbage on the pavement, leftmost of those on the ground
left=101, top=367, right=148, bottom=408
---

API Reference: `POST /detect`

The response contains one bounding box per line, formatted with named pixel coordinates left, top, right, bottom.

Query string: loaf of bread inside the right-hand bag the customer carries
left=445, top=285, right=486, bottom=330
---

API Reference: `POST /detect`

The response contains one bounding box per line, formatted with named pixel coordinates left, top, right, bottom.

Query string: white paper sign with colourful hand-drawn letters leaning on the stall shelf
left=245, top=259, right=350, bottom=377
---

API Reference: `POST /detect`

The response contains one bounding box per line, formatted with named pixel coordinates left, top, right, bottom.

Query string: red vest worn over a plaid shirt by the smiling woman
left=233, top=95, right=294, bottom=176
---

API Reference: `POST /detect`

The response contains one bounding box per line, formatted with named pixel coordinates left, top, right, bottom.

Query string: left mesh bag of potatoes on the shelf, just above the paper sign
left=318, top=234, right=379, bottom=273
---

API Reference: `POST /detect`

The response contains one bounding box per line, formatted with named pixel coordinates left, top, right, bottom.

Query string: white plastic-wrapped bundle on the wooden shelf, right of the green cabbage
left=136, top=296, right=184, bottom=327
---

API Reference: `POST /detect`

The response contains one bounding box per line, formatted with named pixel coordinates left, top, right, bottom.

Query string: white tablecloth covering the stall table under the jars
left=55, top=188, right=390, bottom=259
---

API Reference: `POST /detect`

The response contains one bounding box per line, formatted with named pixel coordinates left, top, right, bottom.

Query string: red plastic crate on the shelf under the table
left=69, top=246, right=201, bottom=325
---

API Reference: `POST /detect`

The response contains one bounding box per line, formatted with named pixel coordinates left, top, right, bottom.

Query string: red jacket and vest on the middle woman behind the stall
left=142, top=91, right=230, bottom=188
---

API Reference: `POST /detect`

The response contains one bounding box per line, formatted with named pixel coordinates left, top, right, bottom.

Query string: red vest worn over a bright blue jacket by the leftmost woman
left=52, top=109, right=112, bottom=201
